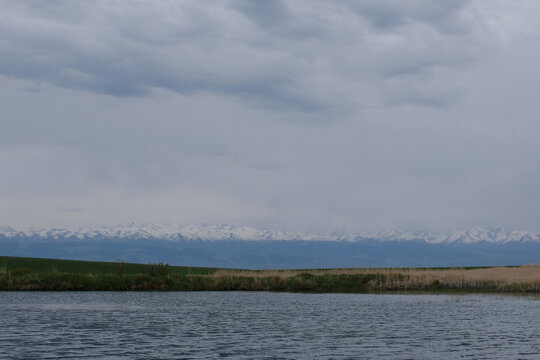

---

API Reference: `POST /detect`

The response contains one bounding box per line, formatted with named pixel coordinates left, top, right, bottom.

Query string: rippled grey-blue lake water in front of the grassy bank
left=0, top=292, right=540, bottom=359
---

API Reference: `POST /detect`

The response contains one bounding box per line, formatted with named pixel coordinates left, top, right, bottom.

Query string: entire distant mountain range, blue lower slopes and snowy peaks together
left=0, top=223, right=540, bottom=269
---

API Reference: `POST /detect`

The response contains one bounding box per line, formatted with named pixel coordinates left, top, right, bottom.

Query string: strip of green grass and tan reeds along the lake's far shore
left=0, top=257, right=540, bottom=293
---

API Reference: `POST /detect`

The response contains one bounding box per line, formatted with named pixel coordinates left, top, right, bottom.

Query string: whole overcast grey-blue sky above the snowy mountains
left=0, top=0, right=540, bottom=232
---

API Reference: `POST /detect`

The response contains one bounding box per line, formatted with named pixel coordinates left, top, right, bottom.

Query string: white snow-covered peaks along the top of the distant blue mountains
left=0, top=223, right=540, bottom=244
